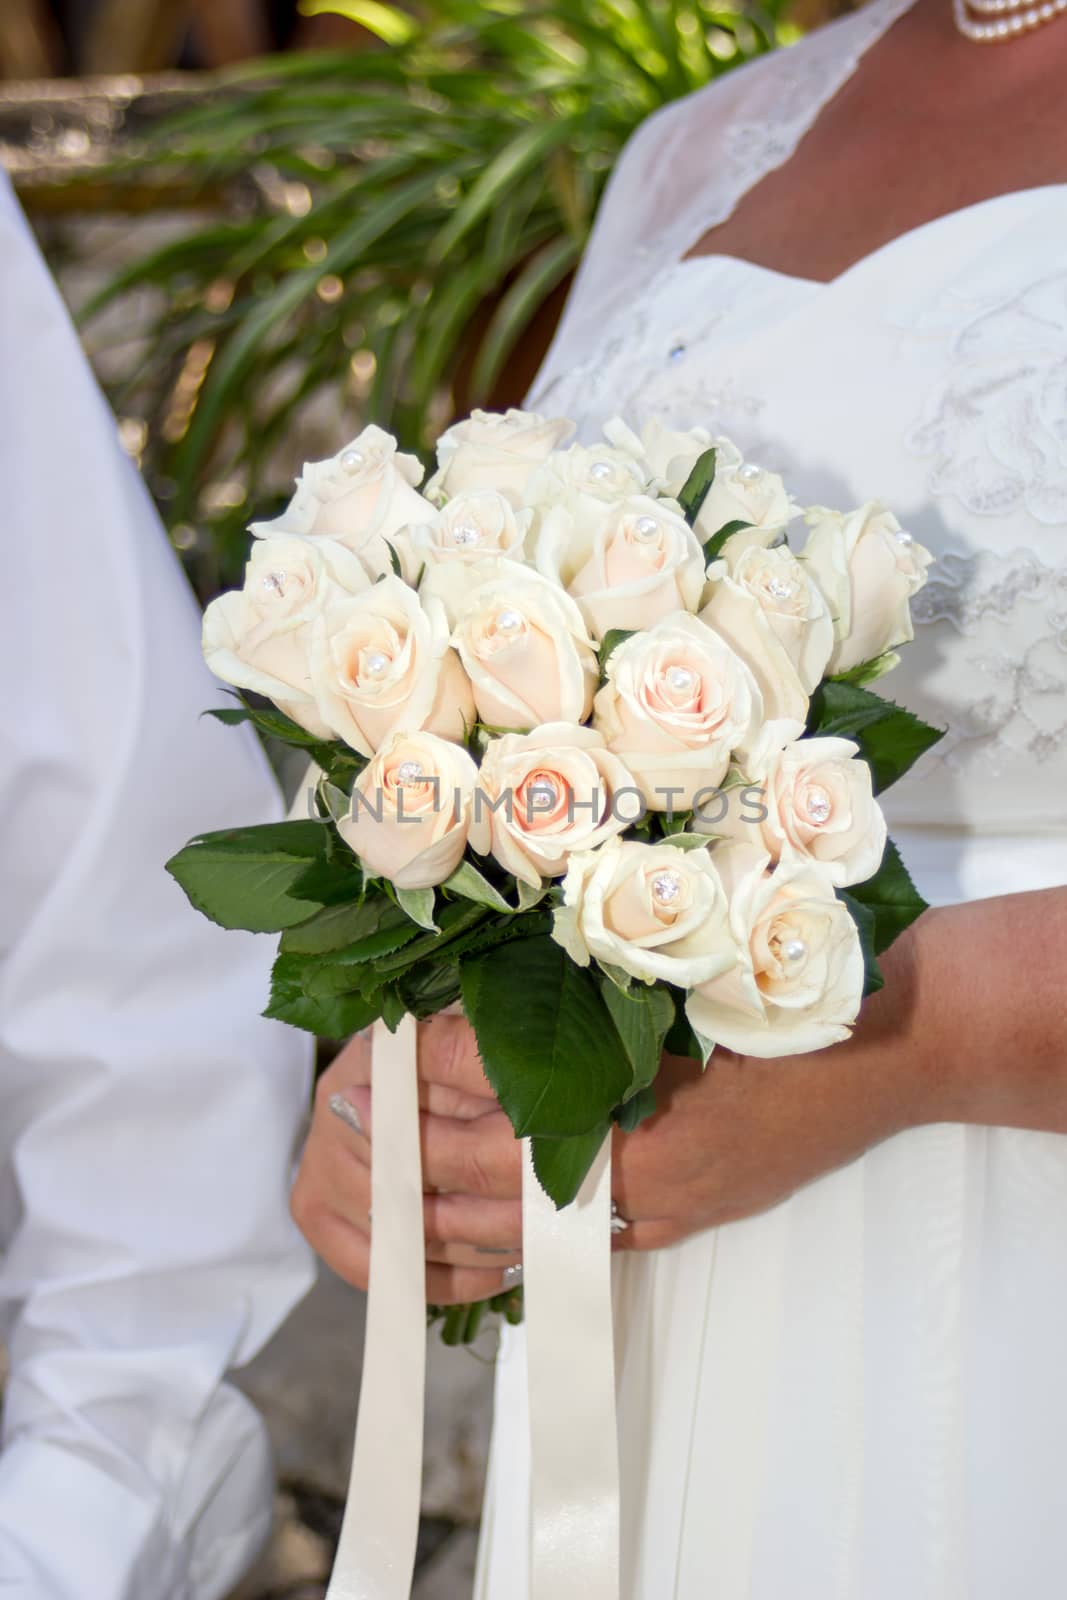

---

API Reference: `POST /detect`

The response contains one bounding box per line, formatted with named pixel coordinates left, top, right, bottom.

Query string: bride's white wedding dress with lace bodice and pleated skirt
left=477, top=0, right=1067, bottom=1600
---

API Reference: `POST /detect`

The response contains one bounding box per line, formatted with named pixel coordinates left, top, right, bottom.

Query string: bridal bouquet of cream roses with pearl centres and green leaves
left=170, top=411, right=937, bottom=1267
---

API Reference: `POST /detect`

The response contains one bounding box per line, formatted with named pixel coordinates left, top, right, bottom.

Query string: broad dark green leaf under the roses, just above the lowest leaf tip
left=461, top=934, right=633, bottom=1138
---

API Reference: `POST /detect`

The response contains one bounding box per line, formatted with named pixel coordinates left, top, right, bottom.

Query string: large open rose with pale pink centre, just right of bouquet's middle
left=593, top=611, right=763, bottom=811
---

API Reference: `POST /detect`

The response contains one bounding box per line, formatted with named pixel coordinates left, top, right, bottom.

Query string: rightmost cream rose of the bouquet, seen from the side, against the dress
left=800, top=501, right=933, bottom=672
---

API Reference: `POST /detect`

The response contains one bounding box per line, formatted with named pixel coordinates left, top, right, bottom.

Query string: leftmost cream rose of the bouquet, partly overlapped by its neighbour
left=203, top=539, right=370, bottom=738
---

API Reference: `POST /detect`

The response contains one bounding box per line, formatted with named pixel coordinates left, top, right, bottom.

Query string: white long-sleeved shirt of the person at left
left=0, top=176, right=310, bottom=1600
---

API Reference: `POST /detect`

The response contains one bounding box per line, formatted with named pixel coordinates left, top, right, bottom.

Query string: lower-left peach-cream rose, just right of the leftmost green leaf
left=338, top=733, right=478, bottom=890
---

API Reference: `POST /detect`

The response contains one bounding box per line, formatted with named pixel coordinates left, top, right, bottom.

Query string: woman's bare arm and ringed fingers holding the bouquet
left=294, top=888, right=1067, bottom=1301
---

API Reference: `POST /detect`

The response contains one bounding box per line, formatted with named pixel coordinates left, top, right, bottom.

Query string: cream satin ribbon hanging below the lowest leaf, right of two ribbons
left=523, top=1136, right=619, bottom=1600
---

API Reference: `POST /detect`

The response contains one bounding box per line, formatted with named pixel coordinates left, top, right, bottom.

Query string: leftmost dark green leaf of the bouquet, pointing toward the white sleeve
left=166, top=821, right=326, bottom=933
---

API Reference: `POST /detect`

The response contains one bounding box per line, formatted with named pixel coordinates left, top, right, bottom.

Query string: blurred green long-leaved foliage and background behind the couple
left=0, top=0, right=797, bottom=598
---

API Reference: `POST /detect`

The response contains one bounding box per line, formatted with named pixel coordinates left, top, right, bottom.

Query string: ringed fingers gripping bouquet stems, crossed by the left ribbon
left=291, top=1016, right=522, bottom=1306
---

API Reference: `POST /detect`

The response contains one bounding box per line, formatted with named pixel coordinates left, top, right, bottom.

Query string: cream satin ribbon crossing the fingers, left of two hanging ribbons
left=326, top=1016, right=426, bottom=1600
